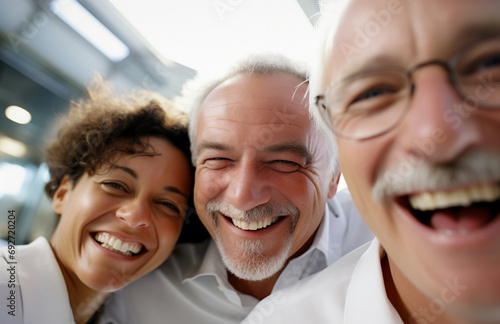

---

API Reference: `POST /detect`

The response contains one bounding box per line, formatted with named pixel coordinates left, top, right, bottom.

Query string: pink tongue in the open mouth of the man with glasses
left=430, top=206, right=491, bottom=232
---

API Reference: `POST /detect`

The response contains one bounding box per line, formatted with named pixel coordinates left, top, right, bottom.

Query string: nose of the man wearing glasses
left=399, top=65, right=481, bottom=164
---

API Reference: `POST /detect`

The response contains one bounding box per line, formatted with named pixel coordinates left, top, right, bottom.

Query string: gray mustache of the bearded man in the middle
left=207, top=200, right=300, bottom=222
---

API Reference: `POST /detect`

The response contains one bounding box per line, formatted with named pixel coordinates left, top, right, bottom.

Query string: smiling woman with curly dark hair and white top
left=0, top=80, right=193, bottom=323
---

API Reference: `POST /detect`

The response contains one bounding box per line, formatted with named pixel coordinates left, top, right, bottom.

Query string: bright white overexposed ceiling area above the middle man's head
left=109, top=0, right=319, bottom=73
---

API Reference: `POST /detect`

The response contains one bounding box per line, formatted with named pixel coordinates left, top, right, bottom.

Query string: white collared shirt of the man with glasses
left=242, top=239, right=403, bottom=324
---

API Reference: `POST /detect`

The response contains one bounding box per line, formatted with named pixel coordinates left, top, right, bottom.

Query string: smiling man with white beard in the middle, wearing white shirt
left=95, top=55, right=373, bottom=324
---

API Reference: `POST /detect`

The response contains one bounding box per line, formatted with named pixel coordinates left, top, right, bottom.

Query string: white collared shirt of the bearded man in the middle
left=97, top=191, right=373, bottom=324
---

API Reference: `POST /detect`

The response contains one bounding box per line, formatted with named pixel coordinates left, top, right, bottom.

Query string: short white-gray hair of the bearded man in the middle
left=180, top=53, right=337, bottom=173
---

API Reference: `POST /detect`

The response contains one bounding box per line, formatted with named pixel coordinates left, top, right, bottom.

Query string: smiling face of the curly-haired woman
left=50, top=137, right=192, bottom=292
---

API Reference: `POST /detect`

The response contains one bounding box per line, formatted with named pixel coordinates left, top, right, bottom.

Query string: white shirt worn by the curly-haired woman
left=0, top=237, right=74, bottom=324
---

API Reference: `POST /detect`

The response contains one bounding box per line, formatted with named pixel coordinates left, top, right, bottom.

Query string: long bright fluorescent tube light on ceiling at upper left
left=50, top=0, right=130, bottom=62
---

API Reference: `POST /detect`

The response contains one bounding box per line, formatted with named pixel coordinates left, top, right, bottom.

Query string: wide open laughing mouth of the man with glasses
left=398, top=183, right=500, bottom=235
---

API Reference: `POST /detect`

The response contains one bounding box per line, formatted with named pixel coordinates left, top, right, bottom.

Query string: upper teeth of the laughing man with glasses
left=409, top=184, right=500, bottom=211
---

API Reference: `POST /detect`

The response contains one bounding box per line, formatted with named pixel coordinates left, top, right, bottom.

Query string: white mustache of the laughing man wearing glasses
left=372, top=151, right=500, bottom=203
